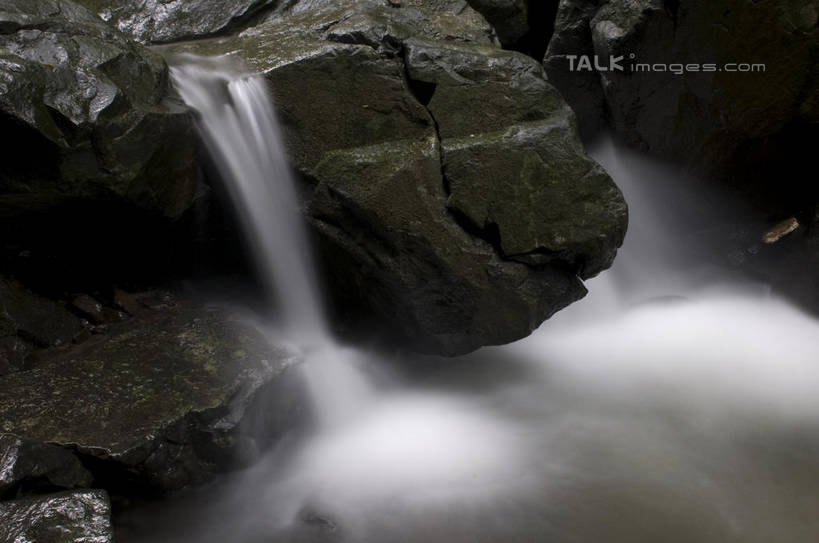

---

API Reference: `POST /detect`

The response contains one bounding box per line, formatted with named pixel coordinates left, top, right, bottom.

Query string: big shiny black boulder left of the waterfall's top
left=0, top=0, right=198, bottom=221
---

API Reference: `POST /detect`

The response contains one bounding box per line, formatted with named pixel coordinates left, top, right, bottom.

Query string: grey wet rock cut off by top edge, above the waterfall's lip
left=78, top=0, right=286, bottom=43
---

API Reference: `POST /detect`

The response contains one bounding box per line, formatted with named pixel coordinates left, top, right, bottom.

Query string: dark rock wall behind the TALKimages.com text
left=545, top=0, right=819, bottom=171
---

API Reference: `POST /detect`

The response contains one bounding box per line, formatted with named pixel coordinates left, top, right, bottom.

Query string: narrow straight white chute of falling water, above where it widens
left=171, top=57, right=327, bottom=342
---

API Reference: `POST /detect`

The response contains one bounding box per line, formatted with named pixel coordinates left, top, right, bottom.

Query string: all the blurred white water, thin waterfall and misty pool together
left=125, top=60, right=819, bottom=543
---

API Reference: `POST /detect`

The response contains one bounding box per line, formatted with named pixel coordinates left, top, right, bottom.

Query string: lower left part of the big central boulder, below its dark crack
left=309, top=137, right=585, bottom=354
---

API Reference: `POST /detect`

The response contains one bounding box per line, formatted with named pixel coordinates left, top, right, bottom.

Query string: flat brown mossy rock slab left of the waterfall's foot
left=0, top=302, right=302, bottom=494
